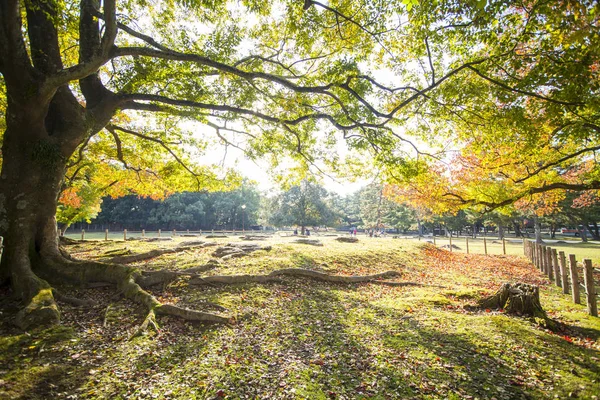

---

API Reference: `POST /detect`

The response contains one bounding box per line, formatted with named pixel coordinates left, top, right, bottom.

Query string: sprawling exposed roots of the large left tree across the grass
left=17, top=244, right=405, bottom=337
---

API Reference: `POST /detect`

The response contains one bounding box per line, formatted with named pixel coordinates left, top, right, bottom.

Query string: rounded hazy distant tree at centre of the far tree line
left=269, top=180, right=339, bottom=234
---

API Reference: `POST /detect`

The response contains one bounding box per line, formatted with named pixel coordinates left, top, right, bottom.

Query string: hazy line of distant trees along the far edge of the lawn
left=71, top=180, right=600, bottom=240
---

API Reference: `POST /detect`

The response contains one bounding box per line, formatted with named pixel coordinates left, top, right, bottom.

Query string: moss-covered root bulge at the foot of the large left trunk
left=15, top=277, right=60, bottom=330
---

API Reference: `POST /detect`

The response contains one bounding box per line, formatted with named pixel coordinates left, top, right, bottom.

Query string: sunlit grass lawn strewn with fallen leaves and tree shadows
left=0, top=237, right=600, bottom=399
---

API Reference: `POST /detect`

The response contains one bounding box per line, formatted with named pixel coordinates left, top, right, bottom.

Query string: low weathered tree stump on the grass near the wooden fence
left=478, top=282, right=549, bottom=325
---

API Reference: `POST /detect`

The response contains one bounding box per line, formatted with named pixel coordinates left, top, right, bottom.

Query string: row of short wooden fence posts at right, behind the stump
left=523, top=240, right=598, bottom=317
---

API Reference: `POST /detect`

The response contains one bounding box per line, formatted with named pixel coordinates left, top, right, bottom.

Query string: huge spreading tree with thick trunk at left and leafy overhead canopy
left=0, top=0, right=600, bottom=327
